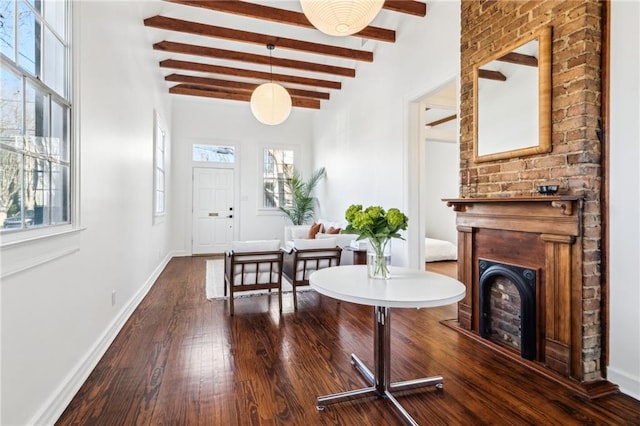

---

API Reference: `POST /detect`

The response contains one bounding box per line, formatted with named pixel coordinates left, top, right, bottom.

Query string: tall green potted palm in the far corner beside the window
left=280, top=167, right=327, bottom=225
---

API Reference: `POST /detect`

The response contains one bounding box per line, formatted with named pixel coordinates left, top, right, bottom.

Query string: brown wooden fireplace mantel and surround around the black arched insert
left=443, top=195, right=604, bottom=396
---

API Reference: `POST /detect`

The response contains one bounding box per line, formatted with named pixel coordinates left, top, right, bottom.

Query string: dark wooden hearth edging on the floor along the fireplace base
left=440, top=320, right=620, bottom=399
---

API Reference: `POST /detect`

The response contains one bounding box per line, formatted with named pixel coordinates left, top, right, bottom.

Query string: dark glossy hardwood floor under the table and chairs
left=57, top=257, right=640, bottom=426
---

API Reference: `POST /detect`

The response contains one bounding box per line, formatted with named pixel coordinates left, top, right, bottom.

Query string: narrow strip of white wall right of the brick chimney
left=607, top=0, right=640, bottom=399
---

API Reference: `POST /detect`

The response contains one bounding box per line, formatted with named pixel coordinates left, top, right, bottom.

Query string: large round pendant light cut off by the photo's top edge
left=300, top=0, right=384, bottom=36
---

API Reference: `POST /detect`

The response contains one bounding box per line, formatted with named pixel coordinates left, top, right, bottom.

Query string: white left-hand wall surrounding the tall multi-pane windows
left=0, top=1, right=172, bottom=425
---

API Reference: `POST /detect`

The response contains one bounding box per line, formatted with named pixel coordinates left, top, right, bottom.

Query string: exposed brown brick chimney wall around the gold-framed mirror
left=460, top=0, right=602, bottom=381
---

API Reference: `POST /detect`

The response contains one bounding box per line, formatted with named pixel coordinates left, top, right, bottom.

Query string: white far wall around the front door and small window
left=172, top=96, right=312, bottom=254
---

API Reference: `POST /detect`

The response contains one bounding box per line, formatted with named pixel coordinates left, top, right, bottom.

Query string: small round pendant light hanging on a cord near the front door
left=251, top=44, right=291, bottom=126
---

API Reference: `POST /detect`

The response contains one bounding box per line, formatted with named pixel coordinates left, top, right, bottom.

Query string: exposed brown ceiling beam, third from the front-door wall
left=160, top=59, right=342, bottom=90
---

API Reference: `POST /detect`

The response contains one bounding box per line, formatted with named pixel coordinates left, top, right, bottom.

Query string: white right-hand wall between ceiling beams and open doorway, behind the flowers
left=313, top=1, right=460, bottom=266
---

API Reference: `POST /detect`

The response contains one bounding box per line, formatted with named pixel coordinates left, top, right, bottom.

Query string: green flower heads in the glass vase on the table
left=344, top=204, right=409, bottom=241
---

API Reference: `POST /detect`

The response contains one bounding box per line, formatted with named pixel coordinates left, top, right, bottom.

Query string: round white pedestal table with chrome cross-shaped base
left=309, top=265, right=466, bottom=425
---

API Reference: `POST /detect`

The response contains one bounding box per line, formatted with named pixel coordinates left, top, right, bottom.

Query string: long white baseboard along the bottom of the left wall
left=28, top=252, right=175, bottom=425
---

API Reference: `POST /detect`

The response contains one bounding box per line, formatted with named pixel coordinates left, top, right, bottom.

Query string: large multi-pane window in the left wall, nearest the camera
left=0, top=0, right=71, bottom=231
